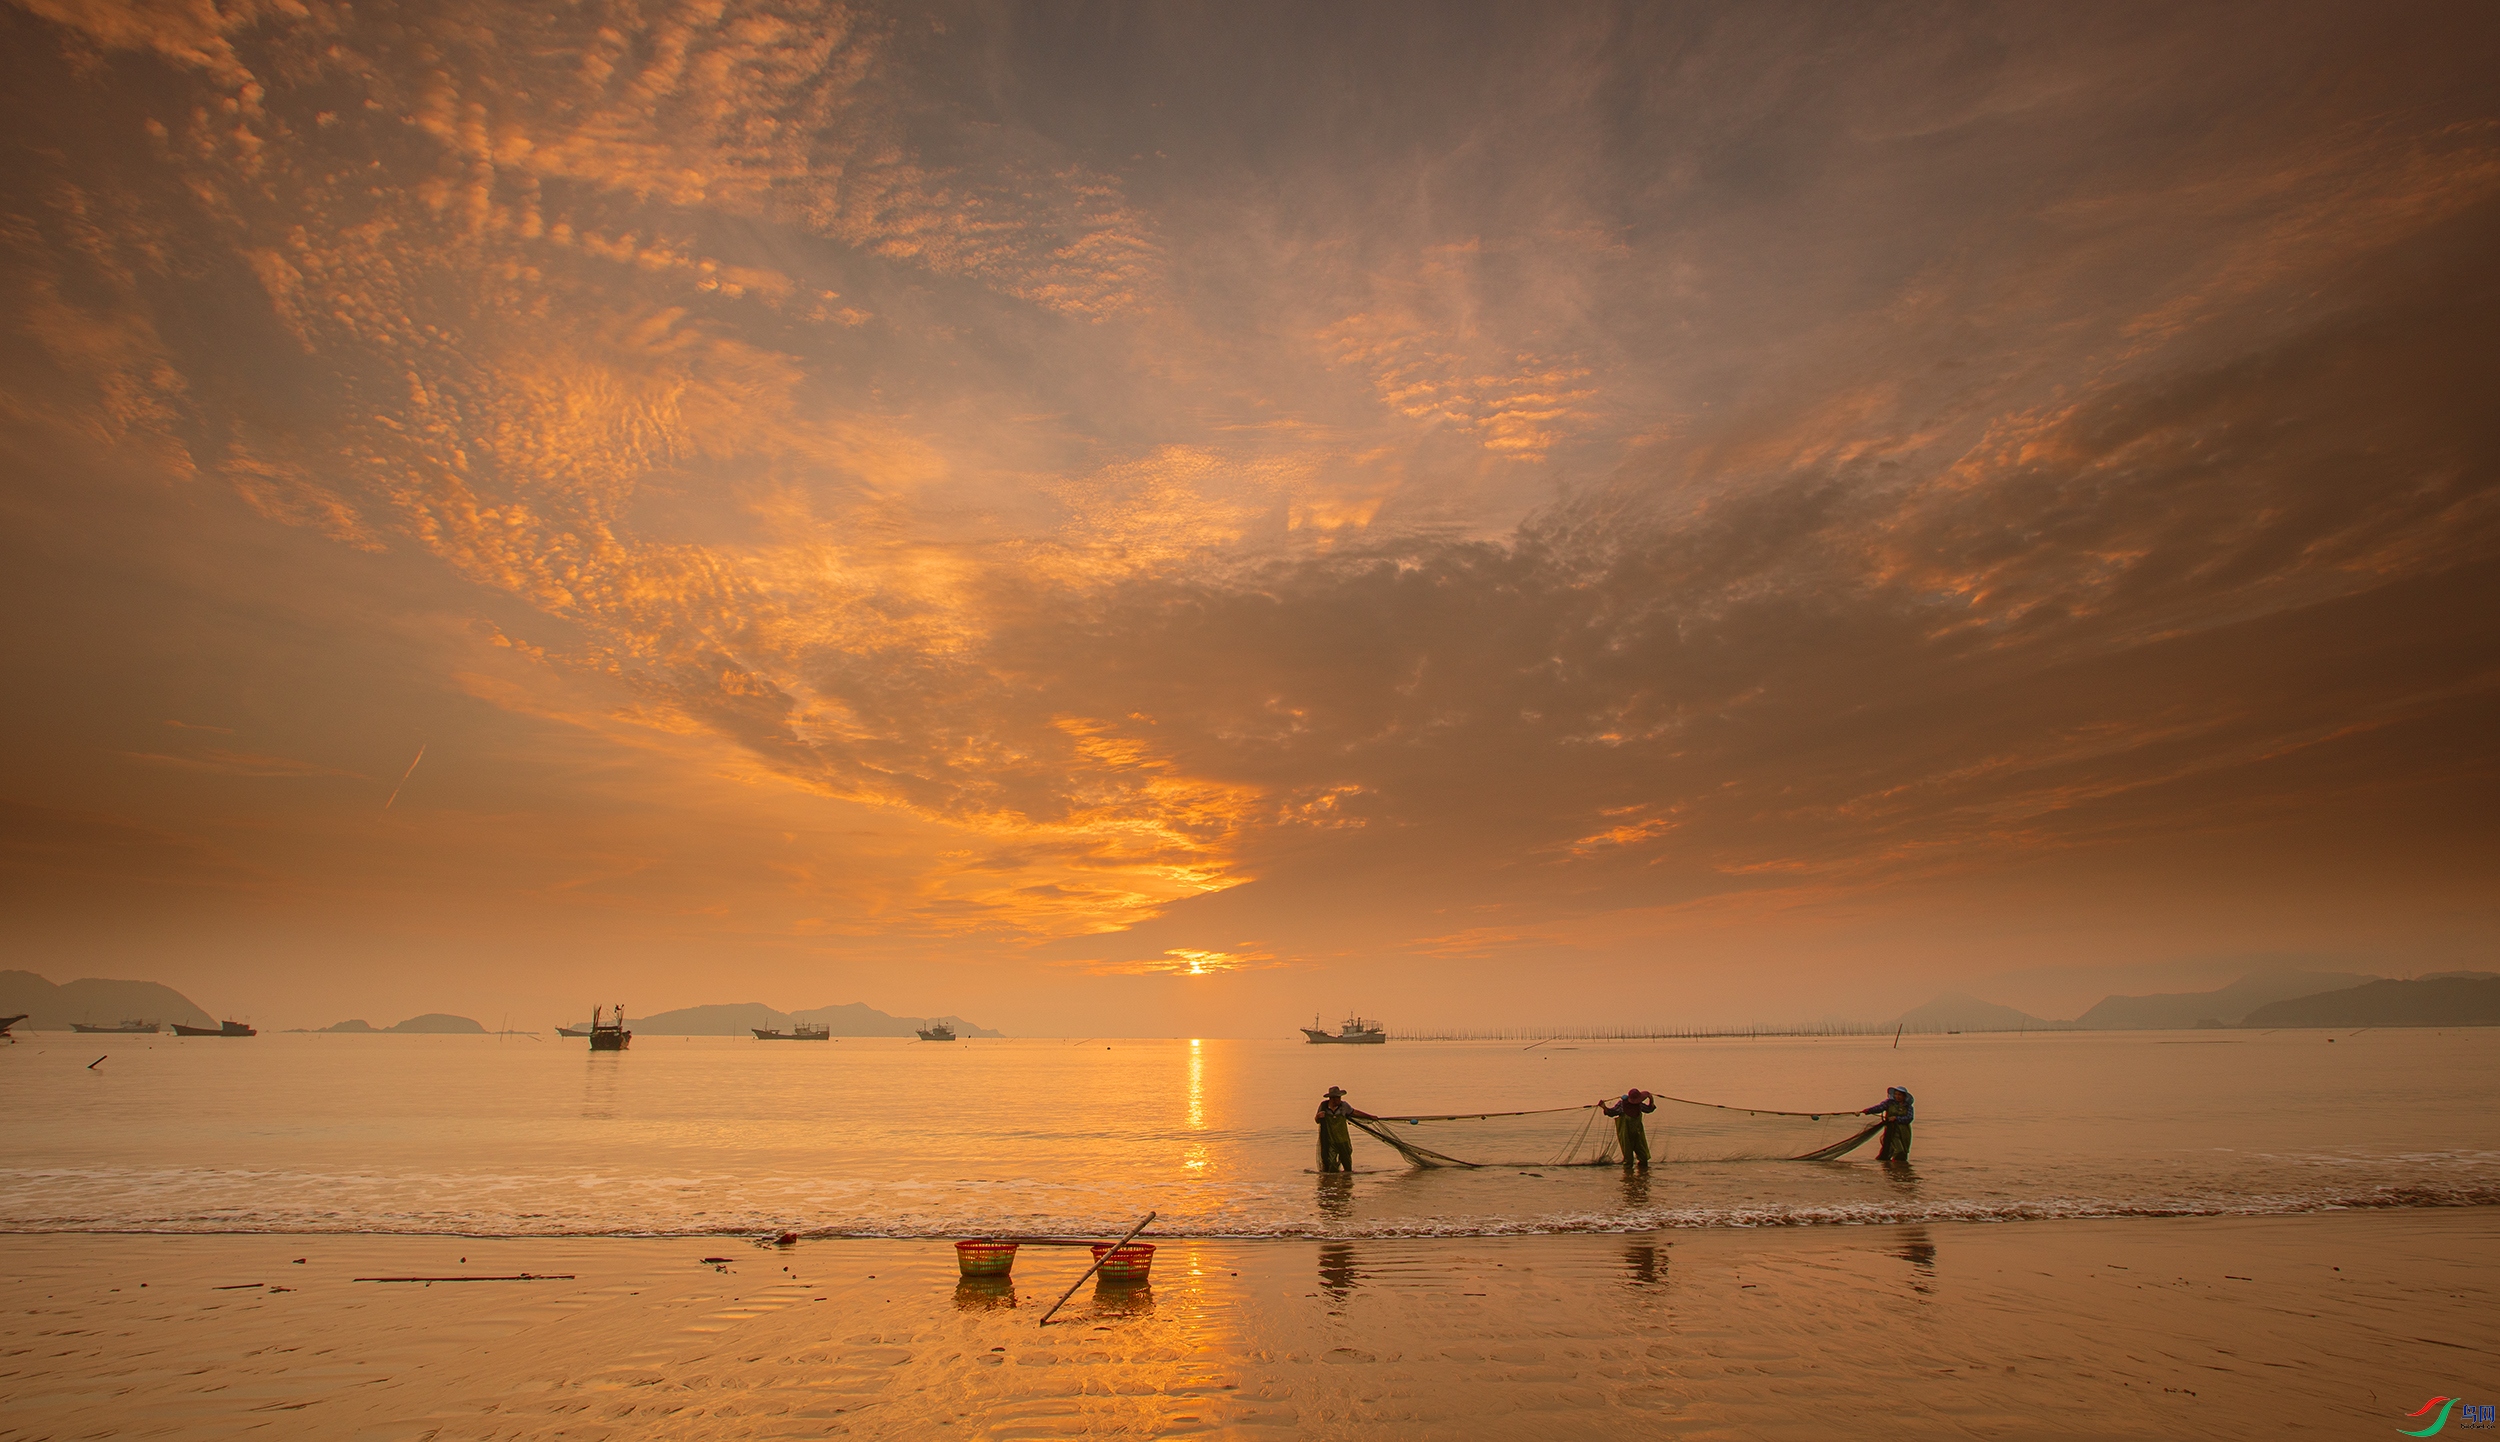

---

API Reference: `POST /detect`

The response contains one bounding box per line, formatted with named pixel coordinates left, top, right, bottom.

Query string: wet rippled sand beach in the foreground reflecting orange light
left=0, top=1207, right=2500, bottom=1440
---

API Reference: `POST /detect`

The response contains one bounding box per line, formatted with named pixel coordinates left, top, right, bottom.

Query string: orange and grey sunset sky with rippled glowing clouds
left=0, top=0, right=2500, bottom=1035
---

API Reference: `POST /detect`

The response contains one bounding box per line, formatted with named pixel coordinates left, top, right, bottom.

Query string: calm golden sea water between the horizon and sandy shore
left=0, top=1030, right=2500, bottom=1237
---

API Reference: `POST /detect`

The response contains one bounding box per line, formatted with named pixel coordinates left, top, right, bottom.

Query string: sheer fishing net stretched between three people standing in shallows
left=1353, top=1097, right=1883, bottom=1167
